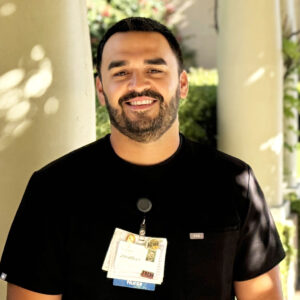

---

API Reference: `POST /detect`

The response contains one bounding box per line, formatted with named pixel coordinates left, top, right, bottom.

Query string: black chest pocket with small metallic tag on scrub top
left=182, top=228, right=239, bottom=299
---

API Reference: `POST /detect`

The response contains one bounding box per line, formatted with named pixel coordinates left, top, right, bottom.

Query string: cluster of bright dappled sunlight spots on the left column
left=0, top=45, right=55, bottom=151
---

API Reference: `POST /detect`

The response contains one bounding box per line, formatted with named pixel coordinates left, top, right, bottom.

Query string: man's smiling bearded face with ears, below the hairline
left=97, top=32, right=187, bottom=143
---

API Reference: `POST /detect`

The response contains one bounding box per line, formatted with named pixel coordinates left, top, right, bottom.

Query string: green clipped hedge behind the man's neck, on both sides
left=96, top=68, right=218, bottom=146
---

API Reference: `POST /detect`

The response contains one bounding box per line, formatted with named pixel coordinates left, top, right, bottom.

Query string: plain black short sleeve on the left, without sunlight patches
left=0, top=173, right=63, bottom=295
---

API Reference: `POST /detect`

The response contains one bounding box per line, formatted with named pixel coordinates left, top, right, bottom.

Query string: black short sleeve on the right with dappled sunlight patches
left=234, top=167, right=285, bottom=281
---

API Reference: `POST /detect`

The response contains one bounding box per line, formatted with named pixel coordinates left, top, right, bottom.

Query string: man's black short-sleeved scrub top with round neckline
left=0, top=135, right=285, bottom=300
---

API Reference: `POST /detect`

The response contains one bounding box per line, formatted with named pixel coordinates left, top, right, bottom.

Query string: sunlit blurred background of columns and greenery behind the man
left=0, top=0, right=300, bottom=300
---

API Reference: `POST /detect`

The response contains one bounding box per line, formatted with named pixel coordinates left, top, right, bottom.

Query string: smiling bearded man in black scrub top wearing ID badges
left=0, top=18, right=284, bottom=300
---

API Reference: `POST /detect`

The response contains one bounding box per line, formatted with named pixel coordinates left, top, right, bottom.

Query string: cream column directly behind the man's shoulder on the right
left=218, top=0, right=283, bottom=206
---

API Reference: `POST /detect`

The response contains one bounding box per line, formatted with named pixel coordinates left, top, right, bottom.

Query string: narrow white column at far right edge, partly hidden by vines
left=281, top=0, right=298, bottom=188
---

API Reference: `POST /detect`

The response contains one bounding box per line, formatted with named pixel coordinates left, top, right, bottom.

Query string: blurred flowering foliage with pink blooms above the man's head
left=87, top=0, right=195, bottom=71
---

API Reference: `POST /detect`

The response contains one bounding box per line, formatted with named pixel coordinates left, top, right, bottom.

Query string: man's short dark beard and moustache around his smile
left=103, top=86, right=180, bottom=143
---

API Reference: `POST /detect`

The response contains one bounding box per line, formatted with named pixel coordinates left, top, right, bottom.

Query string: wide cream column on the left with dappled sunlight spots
left=0, top=0, right=95, bottom=299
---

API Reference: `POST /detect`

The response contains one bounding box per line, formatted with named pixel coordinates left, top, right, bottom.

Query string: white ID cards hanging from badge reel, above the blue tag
left=102, top=228, right=167, bottom=284
